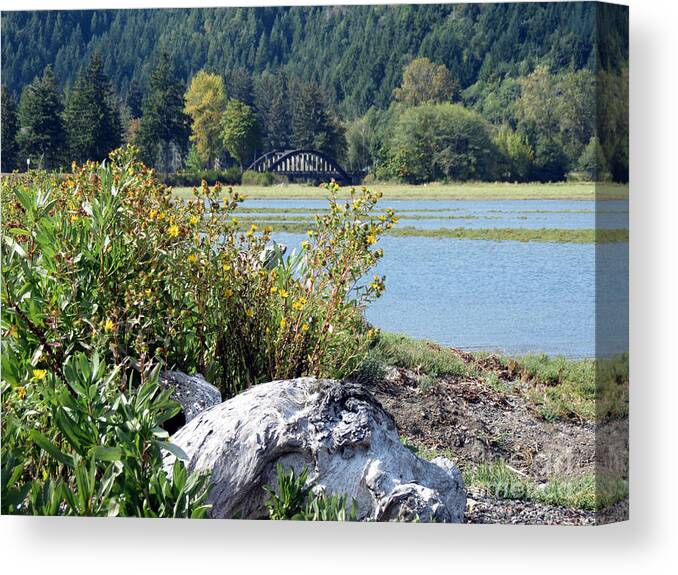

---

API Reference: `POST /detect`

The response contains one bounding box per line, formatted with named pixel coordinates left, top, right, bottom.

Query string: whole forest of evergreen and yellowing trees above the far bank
left=2, top=2, right=628, bottom=183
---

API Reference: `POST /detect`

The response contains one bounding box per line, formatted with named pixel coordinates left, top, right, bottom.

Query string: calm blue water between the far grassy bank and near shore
left=246, top=200, right=628, bottom=357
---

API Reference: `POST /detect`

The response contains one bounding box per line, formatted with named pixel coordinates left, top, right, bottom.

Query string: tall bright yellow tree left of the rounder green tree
left=185, top=70, right=227, bottom=166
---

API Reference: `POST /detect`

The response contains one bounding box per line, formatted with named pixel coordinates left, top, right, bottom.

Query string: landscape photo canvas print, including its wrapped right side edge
left=0, top=2, right=629, bottom=529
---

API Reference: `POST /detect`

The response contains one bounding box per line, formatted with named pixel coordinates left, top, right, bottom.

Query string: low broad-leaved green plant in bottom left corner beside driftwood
left=2, top=352, right=209, bottom=517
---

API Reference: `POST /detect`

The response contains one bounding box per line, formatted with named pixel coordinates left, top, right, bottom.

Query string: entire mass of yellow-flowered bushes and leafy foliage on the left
left=1, top=148, right=395, bottom=516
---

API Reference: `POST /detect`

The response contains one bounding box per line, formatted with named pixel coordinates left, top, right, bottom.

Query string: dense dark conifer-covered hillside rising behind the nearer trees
left=2, top=3, right=628, bottom=118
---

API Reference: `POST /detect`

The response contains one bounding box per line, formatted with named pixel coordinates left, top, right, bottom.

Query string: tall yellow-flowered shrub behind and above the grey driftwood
left=2, top=149, right=395, bottom=395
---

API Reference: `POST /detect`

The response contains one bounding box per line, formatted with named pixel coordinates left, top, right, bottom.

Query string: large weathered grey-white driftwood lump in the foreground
left=165, top=378, right=466, bottom=522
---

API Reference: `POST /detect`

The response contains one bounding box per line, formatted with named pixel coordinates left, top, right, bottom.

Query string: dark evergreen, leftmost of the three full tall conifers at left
left=17, top=66, right=66, bottom=169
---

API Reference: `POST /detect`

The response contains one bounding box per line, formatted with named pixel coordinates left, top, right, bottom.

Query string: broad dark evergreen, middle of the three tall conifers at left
left=64, top=54, right=122, bottom=162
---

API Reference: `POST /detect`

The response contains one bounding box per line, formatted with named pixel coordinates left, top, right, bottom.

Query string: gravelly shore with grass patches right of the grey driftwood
left=362, top=332, right=628, bottom=525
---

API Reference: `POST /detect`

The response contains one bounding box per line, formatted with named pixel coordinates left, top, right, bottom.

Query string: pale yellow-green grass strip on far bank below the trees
left=174, top=182, right=629, bottom=200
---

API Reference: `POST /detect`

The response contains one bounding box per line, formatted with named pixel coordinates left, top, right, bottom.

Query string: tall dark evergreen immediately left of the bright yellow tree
left=139, top=54, right=191, bottom=171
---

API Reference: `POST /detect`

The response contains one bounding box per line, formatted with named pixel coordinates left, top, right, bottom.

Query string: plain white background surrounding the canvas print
left=0, top=0, right=678, bottom=575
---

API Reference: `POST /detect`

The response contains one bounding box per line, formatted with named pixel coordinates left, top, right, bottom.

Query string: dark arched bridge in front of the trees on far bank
left=247, top=149, right=354, bottom=184
